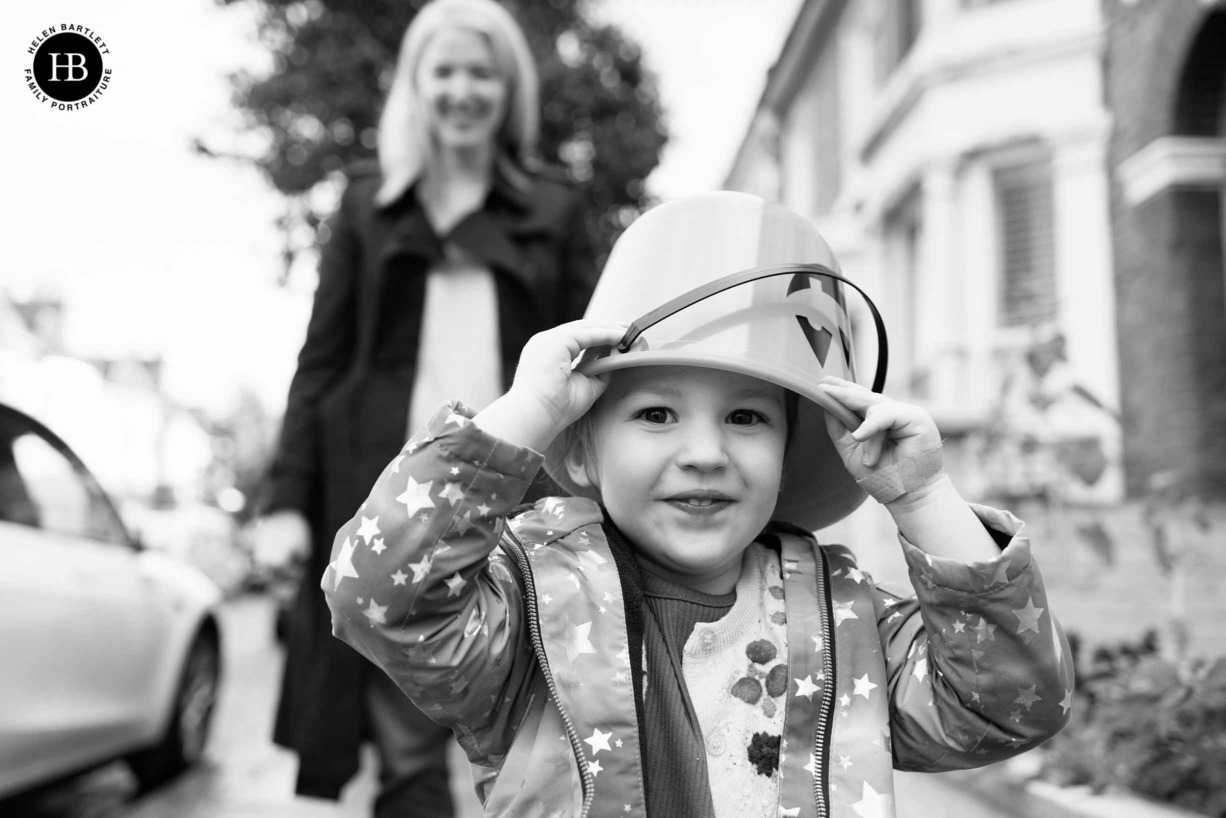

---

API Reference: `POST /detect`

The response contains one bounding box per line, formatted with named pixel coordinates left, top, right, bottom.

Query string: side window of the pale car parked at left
left=0, top=413, right=129, bottom=543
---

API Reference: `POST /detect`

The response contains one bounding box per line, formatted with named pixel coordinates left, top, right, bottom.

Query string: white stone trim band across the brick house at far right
left=1116, top=136, right=1226, bottom=206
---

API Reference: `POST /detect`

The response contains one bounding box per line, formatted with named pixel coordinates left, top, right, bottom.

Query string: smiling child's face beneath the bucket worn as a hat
left=568, top=367, right=787, bottom=594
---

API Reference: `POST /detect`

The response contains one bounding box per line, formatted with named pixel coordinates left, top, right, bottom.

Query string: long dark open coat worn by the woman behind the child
left=266, top=163, right=597, bottom=798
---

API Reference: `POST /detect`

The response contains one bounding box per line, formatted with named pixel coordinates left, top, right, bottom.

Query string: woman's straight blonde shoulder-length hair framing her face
left=375, top=0, right=541, bottom=205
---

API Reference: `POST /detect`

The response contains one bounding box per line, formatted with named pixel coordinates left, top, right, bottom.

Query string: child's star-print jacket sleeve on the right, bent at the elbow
left=878, top=504, right=1073, bottom=771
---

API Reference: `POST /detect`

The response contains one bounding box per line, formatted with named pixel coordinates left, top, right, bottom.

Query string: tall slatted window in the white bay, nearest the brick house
left=992, top=156, right=1057, bottom=326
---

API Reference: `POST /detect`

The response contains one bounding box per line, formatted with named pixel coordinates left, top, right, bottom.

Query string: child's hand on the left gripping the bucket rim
left=473, top=320, right=626, bottom=451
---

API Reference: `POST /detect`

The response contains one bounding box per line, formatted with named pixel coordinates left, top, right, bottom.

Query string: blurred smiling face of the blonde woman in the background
left=417, top=28, right=508, bottom=155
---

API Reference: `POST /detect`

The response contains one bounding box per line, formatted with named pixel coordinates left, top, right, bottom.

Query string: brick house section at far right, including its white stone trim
left=1103, top=0, right=1226, bottom=499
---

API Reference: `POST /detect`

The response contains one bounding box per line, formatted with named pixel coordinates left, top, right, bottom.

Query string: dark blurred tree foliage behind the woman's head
left=215, top=0, right=667, bottom=277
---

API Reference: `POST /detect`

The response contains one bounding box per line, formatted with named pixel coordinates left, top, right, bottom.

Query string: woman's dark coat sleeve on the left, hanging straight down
left=262, top=179, right=362, bottom=514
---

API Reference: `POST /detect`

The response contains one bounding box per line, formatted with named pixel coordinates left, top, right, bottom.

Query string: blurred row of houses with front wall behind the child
left=726, top=0, right=1226, bottom=654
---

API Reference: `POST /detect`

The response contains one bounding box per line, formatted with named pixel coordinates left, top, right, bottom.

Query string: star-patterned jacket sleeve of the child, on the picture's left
left=321, top=403, right=542, bottom=760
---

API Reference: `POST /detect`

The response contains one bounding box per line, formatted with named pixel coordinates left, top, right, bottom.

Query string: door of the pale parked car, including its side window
left=0, top=407, right=156, bottom=774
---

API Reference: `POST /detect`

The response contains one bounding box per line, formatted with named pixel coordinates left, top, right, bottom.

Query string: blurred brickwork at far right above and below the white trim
left=1103, top=0, right=1226, bottom=498
